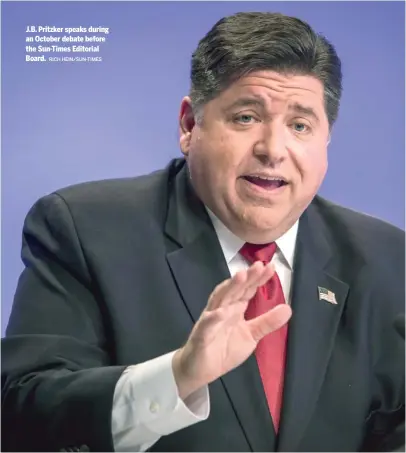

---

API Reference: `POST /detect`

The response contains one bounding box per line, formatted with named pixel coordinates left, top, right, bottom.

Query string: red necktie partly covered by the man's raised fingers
left=240, top=242, right=288, bottom=432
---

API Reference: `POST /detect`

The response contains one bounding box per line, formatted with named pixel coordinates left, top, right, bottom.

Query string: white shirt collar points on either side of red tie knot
left=206, top=207, right=299, bottom=269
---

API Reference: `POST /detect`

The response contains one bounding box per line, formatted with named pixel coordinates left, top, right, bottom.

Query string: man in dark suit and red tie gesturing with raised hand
left=2, top=13, right=405, bottom=451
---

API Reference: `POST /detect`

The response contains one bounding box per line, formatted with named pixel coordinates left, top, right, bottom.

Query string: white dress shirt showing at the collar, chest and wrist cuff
left=111, top=211, right=298, bottom=452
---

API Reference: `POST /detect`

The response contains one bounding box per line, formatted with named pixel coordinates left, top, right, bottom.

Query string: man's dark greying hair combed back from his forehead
left=190, top=12, right=342, bottom=127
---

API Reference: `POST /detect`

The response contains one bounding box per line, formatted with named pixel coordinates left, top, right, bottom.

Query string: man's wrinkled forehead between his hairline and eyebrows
left=217, top=71, right=324, bottom=114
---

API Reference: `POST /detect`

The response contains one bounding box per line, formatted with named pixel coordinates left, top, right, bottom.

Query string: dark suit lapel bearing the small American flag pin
left=278, top=205, right=349, bottom=451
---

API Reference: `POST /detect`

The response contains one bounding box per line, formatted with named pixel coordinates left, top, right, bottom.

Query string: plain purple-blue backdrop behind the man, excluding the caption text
left=1, top=2, right=405, bottom=332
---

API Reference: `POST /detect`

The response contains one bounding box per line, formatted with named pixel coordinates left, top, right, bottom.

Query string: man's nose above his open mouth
left=254, top=124, right=286, bottom=167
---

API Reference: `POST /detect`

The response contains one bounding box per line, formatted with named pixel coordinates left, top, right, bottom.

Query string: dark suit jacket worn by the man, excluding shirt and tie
left=2, top=160, right=405, bottom=451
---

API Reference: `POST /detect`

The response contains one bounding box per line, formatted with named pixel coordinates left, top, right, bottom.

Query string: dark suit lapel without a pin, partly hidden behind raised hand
left=166, top=162, right=275, bottom=451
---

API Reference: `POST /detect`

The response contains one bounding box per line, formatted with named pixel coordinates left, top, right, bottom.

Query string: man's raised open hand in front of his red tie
left=173, top=262, right=292, bottom=399
